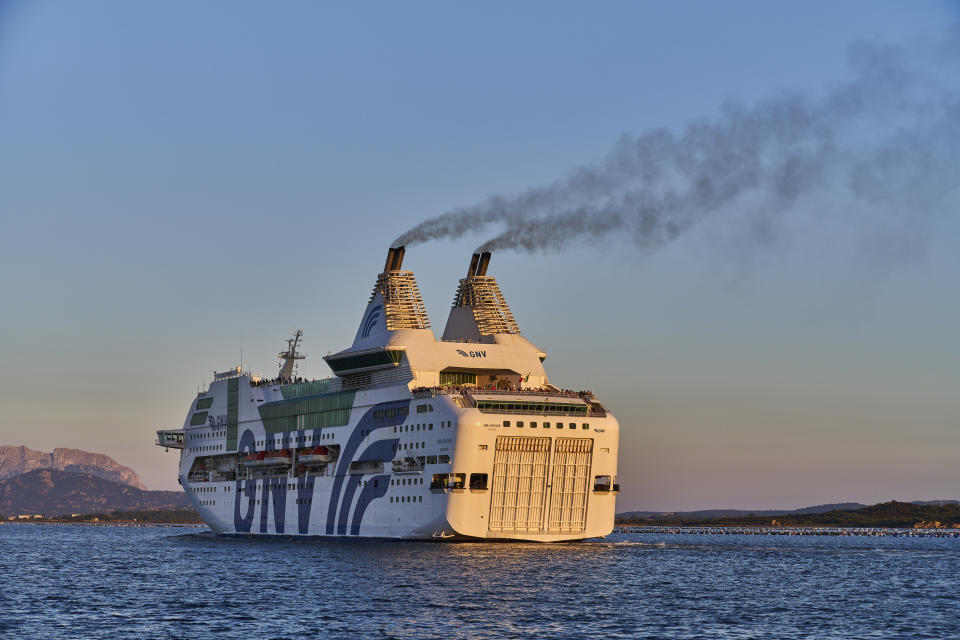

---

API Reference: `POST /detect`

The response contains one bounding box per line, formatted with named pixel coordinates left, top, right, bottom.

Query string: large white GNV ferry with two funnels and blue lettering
left=156, top=247, right=620, bottom=542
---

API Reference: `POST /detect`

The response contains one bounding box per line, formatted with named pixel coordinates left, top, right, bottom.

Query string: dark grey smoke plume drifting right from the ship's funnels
left=394, top=41, right=960, bottom=252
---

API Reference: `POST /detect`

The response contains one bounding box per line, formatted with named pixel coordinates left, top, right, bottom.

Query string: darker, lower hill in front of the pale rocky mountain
left=0, top=469, right=190, bottom=516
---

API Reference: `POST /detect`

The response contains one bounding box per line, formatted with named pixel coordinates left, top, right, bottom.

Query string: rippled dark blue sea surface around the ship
left=0, top=525, right=960, bottom=639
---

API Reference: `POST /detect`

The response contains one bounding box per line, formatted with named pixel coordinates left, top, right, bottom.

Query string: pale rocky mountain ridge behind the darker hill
left=0, top=445, right=147, bottom=491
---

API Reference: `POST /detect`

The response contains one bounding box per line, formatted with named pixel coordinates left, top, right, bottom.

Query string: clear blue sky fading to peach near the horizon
left=0, top=0, right=960, bottom=511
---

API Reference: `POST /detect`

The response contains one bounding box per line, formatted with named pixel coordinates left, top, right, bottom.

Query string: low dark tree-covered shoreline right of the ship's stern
left=617, top=500, right=960, bottom=528
